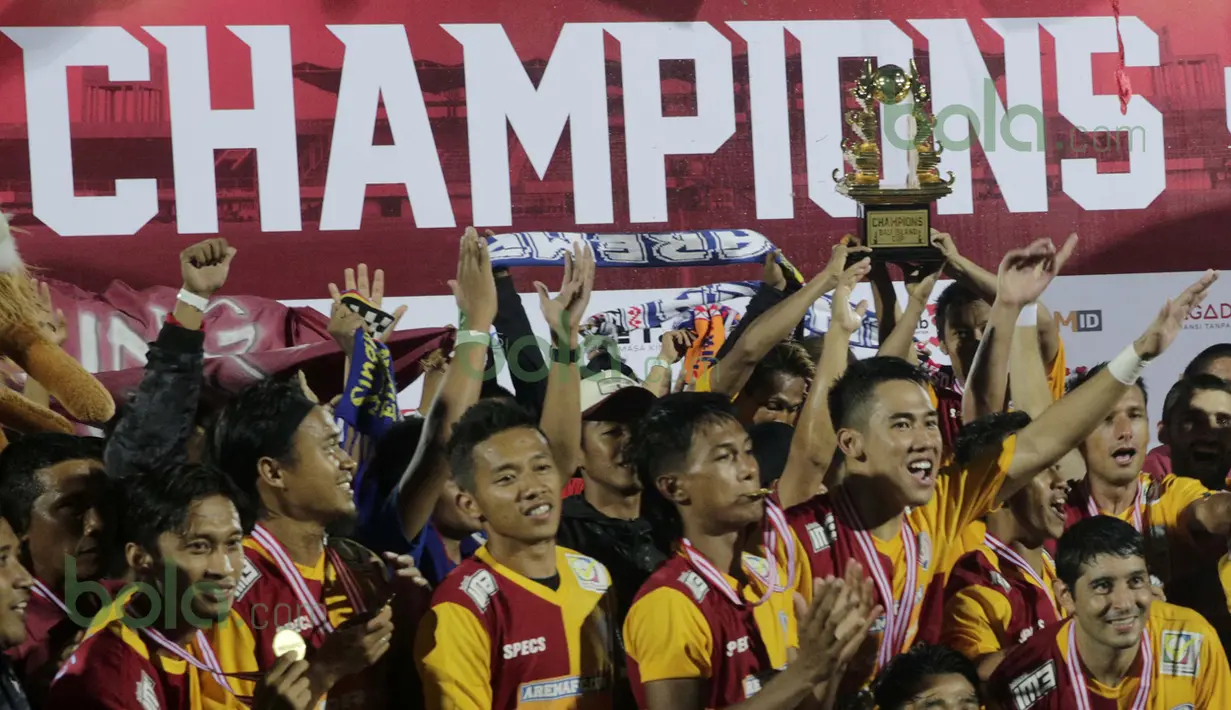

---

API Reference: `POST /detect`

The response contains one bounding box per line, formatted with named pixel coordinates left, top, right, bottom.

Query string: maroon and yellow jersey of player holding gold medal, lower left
left=46, top=585, right=259, bottom=710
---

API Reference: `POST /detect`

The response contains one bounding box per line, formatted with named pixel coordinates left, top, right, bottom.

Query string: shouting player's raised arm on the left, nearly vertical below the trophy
left=778, top=258, right=872, bottom=508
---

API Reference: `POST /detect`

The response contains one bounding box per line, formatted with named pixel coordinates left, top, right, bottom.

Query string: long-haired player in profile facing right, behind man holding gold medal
left=209, top=379, right=394, bottom=708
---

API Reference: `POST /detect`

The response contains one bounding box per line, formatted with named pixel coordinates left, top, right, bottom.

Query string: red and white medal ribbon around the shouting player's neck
left=837, top=490, right=918, bottom=669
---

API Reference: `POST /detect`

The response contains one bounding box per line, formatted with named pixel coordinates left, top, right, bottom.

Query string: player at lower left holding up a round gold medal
left=46, top=465, right=311, bottom=710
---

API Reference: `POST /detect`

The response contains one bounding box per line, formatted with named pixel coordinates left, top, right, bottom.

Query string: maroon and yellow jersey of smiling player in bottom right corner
left=988, top=602, right=1231, bottom=710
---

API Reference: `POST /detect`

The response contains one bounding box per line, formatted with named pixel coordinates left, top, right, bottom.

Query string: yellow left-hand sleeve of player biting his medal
left=624, top=587, right=714, bottom=683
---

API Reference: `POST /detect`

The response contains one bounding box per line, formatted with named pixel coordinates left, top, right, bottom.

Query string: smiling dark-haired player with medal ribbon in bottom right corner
left=988, top=516, right=1231, bottom=710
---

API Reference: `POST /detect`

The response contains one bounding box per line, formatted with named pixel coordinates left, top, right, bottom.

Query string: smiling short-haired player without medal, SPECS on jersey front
left=415, top=400, right=618, bottom=710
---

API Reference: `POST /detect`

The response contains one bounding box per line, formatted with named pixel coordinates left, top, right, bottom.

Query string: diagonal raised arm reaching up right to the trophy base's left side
left=709, top=241, right=870, bottom=396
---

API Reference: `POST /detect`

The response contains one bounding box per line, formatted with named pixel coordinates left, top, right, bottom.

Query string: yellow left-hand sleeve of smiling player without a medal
left=415, top=602, right=491, bottom=710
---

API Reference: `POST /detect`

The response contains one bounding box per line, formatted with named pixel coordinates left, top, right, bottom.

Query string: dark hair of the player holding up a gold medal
left=117, top=464, right=256, bottom=554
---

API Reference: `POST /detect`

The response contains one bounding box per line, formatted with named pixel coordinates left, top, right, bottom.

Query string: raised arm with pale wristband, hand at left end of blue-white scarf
left=393, top=226, right=496, bottom=540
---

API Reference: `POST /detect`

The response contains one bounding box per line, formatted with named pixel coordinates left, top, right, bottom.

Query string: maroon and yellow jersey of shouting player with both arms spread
left=787, top=436, right=1017, bottom=685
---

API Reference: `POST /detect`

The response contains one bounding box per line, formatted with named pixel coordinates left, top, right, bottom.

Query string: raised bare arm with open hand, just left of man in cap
left=534, top=242, right=595, bottom=480
